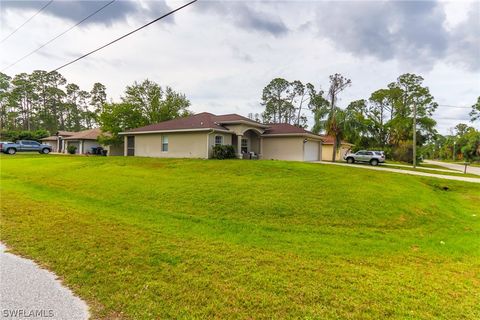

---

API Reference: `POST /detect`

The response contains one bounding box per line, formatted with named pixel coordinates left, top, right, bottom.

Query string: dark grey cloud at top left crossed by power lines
left=2, top=0, right=170, bottom=25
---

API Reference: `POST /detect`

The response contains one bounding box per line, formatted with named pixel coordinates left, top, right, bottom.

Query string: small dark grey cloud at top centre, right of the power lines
left=198, top=1, right=288, bottom=36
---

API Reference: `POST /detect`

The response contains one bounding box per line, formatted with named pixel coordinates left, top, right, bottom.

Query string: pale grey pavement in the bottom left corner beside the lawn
left=0, top=243, right=89, bottom=320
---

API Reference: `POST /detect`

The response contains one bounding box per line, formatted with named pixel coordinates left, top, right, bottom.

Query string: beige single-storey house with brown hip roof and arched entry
left=120, top=112, right=330, bottom=161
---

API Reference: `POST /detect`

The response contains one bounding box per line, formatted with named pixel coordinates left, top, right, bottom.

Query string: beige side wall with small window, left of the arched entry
left=135, top=132, right=208, bottom=158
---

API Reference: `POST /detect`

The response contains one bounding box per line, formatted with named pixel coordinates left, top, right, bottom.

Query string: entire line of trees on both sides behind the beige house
left=0, top=70, right=480, bottom=162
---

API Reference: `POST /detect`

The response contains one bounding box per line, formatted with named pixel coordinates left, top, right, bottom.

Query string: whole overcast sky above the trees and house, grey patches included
left=0, top=0, right=480, bottom=134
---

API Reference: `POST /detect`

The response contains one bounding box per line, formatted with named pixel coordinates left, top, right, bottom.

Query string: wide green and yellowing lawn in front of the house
left=0, top=155, right=480, bottom=319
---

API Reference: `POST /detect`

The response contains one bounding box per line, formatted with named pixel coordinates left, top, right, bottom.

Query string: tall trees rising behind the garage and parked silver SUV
left=256, top=73, right=480, bottom=162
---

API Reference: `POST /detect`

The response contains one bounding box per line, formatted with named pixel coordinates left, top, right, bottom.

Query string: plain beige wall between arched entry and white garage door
left=262, top=137, right=304, bottom=161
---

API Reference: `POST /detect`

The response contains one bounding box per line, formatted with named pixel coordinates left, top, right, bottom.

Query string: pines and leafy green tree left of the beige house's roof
left=0, top=70, right=191, bottom=144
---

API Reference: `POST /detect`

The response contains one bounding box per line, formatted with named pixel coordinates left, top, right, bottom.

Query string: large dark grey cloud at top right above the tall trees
left=315, top=1, right=448, bottom=68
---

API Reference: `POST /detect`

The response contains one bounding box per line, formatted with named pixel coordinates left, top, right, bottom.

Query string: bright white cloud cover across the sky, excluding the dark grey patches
left=0, top=1, right=480, bottom=133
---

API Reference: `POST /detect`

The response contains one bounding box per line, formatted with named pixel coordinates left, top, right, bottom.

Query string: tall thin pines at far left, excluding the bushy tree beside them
left=0, top=70, right=107, bottom=133
